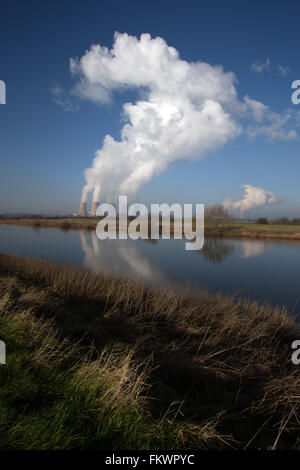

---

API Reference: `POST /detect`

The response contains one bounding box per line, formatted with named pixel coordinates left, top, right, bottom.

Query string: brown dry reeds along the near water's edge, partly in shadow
left=0, top=255, right=300, bottom=449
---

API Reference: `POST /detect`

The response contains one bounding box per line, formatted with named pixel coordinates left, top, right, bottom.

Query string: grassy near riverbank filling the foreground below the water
left=0, top=255, right=300, bottom=450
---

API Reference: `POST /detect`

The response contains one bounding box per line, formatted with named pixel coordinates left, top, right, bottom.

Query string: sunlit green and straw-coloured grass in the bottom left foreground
left=0, top=277, right=230, bottom=450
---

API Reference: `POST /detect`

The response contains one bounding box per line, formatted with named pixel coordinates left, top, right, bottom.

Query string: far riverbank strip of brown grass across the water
left=0, top=217, right=300, bottom=241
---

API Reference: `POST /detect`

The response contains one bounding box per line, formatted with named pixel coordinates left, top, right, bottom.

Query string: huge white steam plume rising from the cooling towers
left=70, top=33, right=240, bottom=202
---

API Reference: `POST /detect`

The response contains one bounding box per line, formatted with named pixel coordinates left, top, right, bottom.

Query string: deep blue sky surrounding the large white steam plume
left=0, top=0, right=300, bottom=217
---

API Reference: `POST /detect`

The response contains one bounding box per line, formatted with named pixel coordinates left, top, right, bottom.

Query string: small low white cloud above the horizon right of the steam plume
left=223, top=184, right=279, bottom=215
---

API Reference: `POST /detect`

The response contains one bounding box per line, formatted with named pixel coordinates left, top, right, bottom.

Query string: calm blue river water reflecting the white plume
left=0, top=225, right=300, bottom=318
